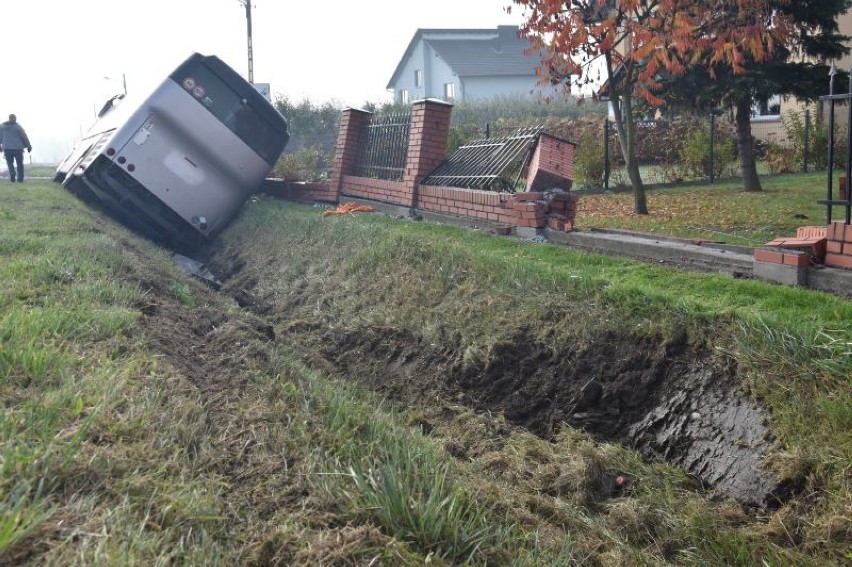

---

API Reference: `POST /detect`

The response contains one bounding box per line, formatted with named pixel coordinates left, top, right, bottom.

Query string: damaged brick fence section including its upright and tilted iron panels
left=272, top=99, right=576, bottom=236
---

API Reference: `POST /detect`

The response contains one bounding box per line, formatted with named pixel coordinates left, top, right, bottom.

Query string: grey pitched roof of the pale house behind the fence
left=388, top=26, right=540, bottom=89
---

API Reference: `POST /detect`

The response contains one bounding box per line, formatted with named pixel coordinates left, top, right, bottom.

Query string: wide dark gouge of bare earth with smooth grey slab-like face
left=462, top=335, right=775, bottom=504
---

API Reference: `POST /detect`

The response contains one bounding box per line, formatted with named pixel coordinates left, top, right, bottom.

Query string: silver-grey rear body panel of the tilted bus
left=101, top=80, right=270, bottom=237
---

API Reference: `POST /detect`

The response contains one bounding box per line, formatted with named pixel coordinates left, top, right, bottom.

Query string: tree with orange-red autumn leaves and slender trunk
left=513, top=0, right=788, bottom=214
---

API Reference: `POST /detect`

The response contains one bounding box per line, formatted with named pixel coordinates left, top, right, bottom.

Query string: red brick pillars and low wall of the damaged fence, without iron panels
left=265, top=99, right=576, bottom=232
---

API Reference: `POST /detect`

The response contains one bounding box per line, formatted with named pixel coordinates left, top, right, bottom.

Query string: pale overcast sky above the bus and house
left=6, top=0, right=522, bottom=164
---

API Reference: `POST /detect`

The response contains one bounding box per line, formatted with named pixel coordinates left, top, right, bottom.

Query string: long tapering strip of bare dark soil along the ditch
left=278, top=322, right=778, bottom=507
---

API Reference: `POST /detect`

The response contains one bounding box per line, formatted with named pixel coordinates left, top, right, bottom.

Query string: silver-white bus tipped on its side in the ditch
left=54, top=53, right=289, bottom=248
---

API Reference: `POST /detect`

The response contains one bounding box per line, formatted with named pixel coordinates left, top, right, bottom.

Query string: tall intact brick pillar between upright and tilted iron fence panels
left=402, top=98, right=453, bottom=208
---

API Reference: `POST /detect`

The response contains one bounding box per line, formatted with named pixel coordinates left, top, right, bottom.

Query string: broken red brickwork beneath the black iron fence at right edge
left=754, top=221, right=852, bottom=269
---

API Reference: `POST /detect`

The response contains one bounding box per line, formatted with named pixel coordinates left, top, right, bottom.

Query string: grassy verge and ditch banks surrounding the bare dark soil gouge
left=0, top=182, right=852, bottom=565
